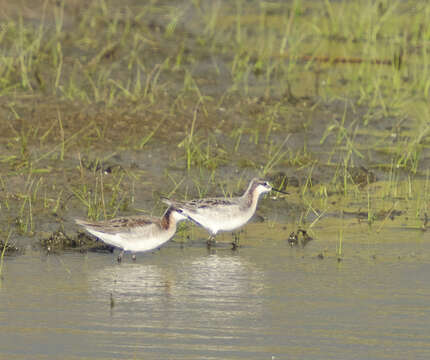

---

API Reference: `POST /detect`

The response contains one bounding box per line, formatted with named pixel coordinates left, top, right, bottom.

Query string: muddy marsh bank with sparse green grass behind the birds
left=0, top=0, right=430, bottom=258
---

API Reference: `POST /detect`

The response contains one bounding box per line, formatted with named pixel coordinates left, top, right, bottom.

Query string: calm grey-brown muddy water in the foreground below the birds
left=0, top=223, right=430, bottom=359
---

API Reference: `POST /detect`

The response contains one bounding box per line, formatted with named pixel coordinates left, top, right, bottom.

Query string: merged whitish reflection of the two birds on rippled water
left=89, top=253, right=264, bottom=328
